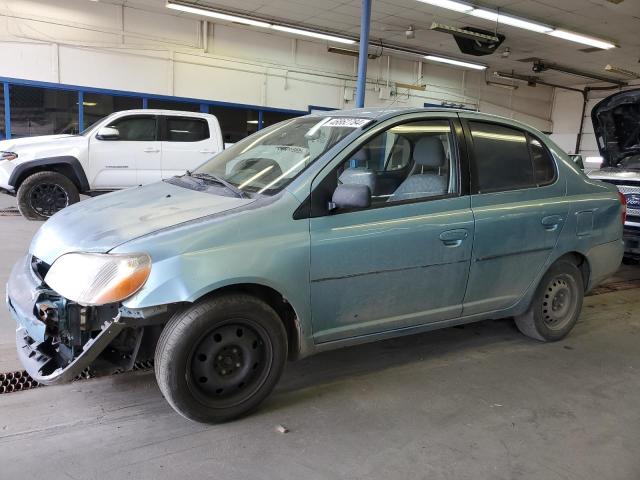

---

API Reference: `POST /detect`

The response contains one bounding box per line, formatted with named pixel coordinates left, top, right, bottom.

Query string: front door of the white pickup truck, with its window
left=88, top=114, right=162, bottom=190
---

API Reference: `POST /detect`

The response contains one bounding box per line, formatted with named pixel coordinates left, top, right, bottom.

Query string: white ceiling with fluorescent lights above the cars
left=149, top=0, right=640, bottom=85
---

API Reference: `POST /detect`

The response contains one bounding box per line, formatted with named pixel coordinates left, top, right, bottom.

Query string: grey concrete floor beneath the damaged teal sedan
left=0, top=192, right=640, bottom=480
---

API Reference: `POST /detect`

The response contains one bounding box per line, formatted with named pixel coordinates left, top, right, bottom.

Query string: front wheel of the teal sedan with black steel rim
left=155, top=294, right=287, bottom=423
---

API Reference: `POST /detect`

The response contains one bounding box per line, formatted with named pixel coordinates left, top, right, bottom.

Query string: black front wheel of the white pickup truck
left=17, top=172, right=80, bottom=220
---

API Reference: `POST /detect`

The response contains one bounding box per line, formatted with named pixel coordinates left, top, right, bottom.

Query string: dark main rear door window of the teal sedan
left=469, top=122, right=536, bottom=193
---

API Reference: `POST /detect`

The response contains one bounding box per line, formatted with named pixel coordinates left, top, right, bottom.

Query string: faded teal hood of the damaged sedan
left=29, top=182, right=255, bottom=264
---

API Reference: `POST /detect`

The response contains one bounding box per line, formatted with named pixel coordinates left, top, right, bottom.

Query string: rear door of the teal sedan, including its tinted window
left=463, top=117, right=569, bottom=315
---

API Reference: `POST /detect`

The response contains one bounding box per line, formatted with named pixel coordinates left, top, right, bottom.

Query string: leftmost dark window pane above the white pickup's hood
left=10, top=85, right=78, bottom=137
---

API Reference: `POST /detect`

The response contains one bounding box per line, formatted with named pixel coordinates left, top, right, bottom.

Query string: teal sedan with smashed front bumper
left=7, top=109, right=625, bottom=423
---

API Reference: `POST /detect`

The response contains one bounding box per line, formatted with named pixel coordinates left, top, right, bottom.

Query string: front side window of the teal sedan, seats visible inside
left=330, top=120, right=456, bottom=206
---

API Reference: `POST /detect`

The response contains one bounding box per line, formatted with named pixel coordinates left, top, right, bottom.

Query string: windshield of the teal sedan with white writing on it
left=193, top=116, right=370, bottom=195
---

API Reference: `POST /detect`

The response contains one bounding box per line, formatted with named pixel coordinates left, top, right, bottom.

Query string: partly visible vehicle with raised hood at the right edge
left=588, top=89, right=640, bottom=260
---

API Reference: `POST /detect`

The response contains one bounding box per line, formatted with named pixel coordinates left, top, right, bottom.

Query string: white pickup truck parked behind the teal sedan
left=0, top=110, right=224, bottom=220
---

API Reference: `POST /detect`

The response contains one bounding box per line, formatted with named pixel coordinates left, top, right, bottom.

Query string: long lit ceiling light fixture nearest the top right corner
left=418, top=0, right=617, bottom=50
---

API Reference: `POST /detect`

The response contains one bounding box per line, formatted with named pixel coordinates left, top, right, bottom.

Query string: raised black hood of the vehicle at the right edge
left=591, top=89, right=640, bottom=169
